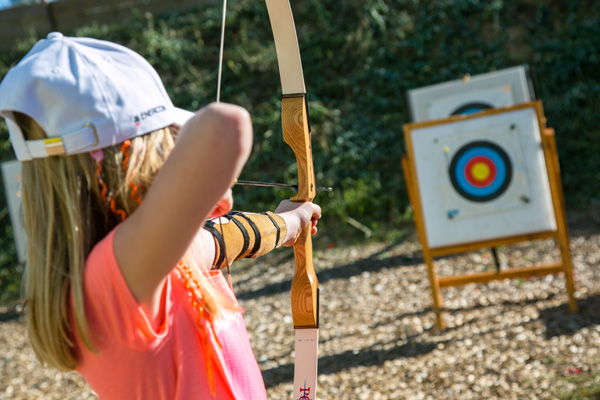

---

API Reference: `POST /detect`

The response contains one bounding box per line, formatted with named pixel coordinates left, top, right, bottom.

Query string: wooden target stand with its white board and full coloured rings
left=402, top=101, right=578, bottom=329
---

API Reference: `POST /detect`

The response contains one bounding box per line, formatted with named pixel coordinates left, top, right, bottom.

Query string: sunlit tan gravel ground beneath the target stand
left=0, top=210, right=600, bottom=400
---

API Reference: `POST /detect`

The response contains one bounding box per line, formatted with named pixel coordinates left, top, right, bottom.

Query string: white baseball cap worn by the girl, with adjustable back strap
left=0, top=32, right=194, bottom=161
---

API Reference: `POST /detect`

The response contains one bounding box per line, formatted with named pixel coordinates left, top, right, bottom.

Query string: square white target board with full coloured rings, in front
left=410, top=103, right=556, bottom=248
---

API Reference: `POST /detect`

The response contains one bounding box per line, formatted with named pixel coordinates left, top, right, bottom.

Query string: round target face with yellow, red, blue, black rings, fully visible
left=448, top=140, right=512, bottom=202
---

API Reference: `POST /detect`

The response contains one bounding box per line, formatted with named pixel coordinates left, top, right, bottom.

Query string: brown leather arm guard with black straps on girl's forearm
left=204, top=211, right=287, bottom=269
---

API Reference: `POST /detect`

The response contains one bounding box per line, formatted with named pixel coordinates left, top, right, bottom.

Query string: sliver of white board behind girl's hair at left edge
left=2, top=161, right=27, bottom=264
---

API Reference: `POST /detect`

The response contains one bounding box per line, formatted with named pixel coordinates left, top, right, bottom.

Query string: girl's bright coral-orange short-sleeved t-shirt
left=71, top=228, right=266, bottom=400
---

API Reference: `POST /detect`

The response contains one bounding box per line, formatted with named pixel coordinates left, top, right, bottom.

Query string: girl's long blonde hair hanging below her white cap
left=15, top=113, right=235, bottom=371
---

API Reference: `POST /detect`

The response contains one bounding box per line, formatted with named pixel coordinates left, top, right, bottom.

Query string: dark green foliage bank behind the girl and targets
left=0, top=0, right=600, bottom=304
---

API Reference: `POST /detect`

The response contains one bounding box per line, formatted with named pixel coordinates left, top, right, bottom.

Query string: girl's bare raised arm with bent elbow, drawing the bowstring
left=114, top=103, right=252, bottom=314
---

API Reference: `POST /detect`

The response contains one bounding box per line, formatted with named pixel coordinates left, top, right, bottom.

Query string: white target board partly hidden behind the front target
left=407, top=66, right=534, bottom=122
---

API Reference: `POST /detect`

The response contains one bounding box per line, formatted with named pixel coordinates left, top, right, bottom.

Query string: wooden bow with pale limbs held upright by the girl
left=265, top=0, right=319, bottom=399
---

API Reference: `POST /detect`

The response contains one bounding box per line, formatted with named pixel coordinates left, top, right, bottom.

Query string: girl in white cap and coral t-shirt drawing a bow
left=0, top=33, right=320, bottom=399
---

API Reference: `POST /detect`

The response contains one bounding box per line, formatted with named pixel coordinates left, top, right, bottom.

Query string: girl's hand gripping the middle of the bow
left=275, top=200, right=321, bottom=247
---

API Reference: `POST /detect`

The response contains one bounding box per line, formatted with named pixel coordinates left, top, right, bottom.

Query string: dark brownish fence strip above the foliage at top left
left=0, top=0, right=213, bottom=49
